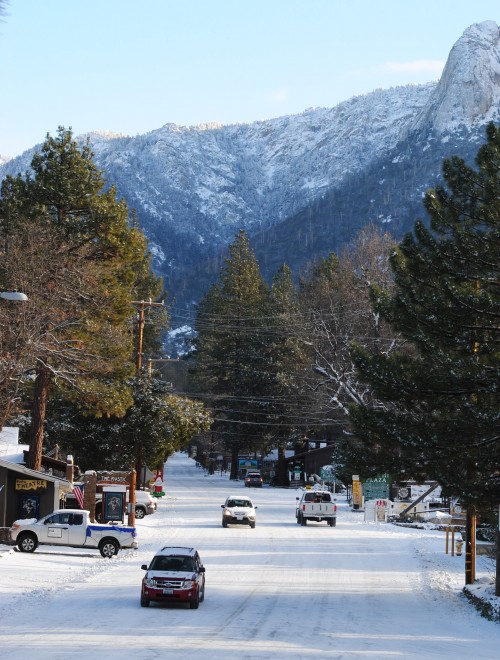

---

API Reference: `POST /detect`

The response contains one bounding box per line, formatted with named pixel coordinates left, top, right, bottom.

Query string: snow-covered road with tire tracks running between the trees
left=0, top=454, right=500, bottom=660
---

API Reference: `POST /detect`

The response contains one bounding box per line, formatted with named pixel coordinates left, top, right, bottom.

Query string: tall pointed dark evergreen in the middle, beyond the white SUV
left=189, top=231, right=269, bottom=479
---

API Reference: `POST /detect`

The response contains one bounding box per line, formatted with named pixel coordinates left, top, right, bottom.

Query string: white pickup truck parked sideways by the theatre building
left=10, top=509, right=138, bottom=557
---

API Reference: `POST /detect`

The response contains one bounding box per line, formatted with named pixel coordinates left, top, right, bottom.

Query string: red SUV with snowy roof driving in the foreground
left=141, top=546, right=205, bottom=610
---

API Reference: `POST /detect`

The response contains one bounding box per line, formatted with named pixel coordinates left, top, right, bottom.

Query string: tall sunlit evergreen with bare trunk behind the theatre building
left=0, top=128, right=162, bottom=469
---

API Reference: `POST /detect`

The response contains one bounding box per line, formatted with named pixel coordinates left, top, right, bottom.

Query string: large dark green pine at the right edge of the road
left=351, top=124, right=500, bottom=507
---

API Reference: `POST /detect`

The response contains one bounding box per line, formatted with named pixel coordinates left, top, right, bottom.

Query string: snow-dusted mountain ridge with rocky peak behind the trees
left=0, top=21, right=500, bottom=318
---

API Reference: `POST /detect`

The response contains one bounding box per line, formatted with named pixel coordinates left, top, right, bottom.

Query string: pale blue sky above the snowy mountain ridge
left=0, top=0, right=500, bottom=157
